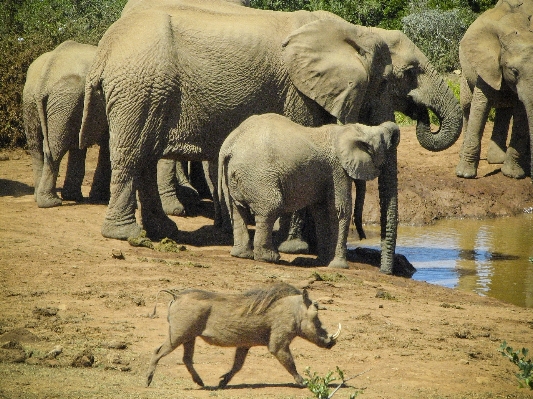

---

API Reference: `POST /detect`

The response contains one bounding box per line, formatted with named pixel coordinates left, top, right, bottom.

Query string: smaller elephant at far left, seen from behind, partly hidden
left=22, top=40, right=111, bottom=208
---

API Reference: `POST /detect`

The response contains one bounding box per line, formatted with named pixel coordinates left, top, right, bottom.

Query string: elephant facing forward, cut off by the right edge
left=456, top=1, right=533, bottom=179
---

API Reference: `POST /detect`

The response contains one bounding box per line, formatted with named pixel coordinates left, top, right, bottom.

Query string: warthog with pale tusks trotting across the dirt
left=146, top=283, right=341, bottom=388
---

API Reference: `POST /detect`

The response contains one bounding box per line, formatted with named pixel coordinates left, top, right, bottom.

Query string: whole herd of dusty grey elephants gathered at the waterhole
left=23, top=0, right=533, bottom=274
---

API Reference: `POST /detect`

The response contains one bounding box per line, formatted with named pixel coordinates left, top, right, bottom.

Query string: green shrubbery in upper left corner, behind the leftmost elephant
left=0, top=0, right=126, bottom=148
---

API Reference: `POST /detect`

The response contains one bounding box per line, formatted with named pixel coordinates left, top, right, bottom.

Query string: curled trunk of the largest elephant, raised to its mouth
left=409, top=65, right=463, bottom=151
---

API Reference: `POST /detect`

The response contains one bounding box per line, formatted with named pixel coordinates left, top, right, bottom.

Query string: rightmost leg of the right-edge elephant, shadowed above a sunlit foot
left=502, top=102, right=529, bottom=179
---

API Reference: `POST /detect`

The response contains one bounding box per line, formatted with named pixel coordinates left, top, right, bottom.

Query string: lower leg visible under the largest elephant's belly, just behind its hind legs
left=157, top=159, right=185, bottom=216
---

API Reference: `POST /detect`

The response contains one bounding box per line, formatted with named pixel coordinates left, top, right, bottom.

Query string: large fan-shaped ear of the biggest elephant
left=282, top=19, right=385, bottom=123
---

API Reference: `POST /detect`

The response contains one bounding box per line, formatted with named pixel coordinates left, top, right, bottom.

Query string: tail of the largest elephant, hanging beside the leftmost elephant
left=79, top=69, right=108, bottom=148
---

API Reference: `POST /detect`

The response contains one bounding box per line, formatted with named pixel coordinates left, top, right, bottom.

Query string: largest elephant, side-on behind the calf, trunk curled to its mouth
left=80, top=0, right=460, bottom=244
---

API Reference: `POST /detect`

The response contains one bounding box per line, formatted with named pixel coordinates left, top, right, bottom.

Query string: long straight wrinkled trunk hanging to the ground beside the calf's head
left=378, top=148, right=398, bottom=274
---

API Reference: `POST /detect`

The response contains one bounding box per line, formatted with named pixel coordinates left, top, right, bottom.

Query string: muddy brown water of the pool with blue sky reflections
left=348, top=214, right=533, bottom=308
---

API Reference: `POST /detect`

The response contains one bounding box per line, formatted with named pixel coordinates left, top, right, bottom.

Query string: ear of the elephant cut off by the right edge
left=460, top=7, right=507, bottom=90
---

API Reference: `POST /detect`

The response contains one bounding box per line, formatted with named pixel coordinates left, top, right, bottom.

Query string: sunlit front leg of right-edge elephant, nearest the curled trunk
left=455, top=83, right=490, bottom=179
